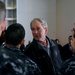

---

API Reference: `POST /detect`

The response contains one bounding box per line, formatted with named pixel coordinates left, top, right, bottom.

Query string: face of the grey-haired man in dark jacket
left=31, top=21, right=48, bottom=41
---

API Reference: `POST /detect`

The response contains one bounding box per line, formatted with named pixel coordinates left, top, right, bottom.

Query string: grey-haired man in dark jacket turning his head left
left=25, top=18, right=61, bottom=75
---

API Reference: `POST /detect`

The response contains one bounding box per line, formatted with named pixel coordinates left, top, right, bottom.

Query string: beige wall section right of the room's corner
left=56, top=0, right=75, bottom=45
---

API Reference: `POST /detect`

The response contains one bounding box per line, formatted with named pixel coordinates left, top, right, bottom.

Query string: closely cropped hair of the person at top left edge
left=0, top=1, right=6, bottom=24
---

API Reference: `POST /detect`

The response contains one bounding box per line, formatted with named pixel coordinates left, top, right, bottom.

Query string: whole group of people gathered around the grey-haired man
left=0, top=1, right=75, bottom=75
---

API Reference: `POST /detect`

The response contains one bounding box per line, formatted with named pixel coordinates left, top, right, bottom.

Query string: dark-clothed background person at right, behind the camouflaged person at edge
left=62, top=35, right=74, bottom=61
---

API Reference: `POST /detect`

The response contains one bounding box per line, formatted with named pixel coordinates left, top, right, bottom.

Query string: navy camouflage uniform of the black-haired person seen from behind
left=0, top=46, right=41, bottom=75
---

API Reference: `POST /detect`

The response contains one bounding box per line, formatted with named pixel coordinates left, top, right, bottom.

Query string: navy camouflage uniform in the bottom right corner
left=60, top=57, right=75, bottom=75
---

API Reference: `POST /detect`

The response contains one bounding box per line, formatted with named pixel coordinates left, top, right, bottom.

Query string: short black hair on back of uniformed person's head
left=5, top=23, right=25, bottom=46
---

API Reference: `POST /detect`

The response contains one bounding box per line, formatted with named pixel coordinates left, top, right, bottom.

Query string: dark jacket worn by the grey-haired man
left=25, top=37, right=62, bottom=75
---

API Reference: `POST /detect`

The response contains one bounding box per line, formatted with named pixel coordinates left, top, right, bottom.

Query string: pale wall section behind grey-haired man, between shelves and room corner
left=17, top=0, right=56, bottom=44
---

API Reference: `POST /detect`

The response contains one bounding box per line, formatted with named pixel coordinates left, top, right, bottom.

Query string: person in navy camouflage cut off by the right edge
left=60, top=26, right=75, bottom=75
